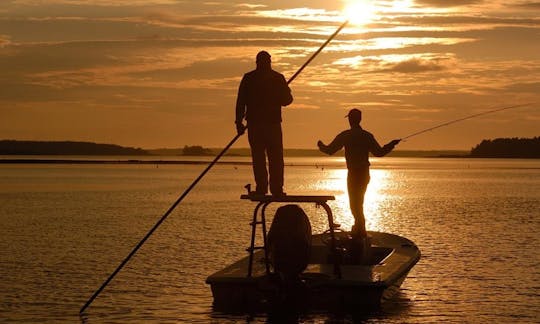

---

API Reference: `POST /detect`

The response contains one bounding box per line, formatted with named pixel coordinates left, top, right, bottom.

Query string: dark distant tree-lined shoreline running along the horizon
left=0, top=137, right=540, bottom=159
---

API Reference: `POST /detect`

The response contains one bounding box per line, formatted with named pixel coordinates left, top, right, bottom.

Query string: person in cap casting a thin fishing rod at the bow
left=317, top=108, right=401, bottom=239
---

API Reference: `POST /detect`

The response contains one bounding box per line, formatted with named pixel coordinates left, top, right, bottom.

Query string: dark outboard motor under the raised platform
left=268, top=205, right=311, bottom=280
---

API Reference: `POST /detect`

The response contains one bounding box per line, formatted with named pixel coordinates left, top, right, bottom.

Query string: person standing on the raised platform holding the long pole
left=235, top=51, right=293, bottom=196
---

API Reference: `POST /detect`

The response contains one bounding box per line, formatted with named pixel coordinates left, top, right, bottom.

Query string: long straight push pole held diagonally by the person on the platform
left=79, top=20, right=349, bottom=315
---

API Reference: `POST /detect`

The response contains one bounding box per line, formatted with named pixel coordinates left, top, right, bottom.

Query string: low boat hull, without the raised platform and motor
left=206, top=232, right=420, bottom=312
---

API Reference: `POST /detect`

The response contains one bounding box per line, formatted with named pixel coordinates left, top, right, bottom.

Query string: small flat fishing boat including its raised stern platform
left=206, top=193, right=420, bottom=312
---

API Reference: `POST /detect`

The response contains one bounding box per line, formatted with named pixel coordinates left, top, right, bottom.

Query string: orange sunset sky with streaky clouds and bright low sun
left=0, top=0, right=540, bottom=150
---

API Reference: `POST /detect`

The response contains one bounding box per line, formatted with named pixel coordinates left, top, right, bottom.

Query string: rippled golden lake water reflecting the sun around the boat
left=0, top=158, right=540, bottom=323
